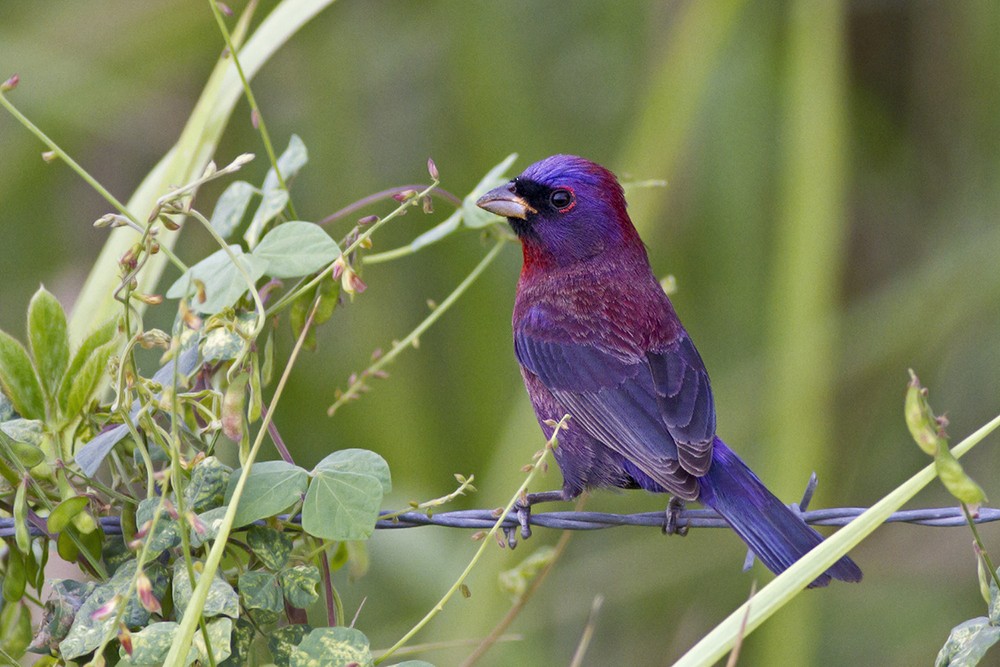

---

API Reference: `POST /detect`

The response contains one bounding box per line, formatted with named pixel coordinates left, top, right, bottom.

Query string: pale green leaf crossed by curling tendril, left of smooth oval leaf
left=167, top=245, right=266, bottom=315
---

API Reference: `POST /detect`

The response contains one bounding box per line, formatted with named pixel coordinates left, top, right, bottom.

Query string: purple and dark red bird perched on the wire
left=477, top=155, right=861, bottom=587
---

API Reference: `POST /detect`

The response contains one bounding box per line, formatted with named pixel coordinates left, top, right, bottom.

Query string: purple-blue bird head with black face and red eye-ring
left=476, top=155, right=642, bottom=270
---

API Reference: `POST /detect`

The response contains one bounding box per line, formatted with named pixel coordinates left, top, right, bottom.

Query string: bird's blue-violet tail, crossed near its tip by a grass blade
left=698, top=438, right=861, bottom=588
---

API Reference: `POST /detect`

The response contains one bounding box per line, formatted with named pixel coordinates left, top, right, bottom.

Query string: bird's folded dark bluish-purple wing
left=514, top=328, right=715, bottom=497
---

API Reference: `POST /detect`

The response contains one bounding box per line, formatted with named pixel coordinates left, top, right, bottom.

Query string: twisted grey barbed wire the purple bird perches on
left=0, top=505, right=1000, bottom=538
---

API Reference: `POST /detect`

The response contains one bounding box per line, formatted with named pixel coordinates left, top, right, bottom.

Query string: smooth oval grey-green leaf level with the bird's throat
left=253, top=220, right=340, bottom=278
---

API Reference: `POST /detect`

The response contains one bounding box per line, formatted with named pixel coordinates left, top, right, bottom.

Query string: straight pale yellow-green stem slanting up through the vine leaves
left=164, top=301, right=319, bottom=667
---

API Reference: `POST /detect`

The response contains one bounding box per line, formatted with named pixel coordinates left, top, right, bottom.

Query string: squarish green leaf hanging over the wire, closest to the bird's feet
left=302, top=470, right=383, bottom=540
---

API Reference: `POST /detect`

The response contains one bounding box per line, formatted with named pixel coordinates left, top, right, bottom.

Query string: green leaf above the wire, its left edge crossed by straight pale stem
left=226, top=461, right=309, bottom=528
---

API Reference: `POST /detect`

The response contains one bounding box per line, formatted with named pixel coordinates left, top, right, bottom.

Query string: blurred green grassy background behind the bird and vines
left=0, top=0, right=1000, bottom=666
